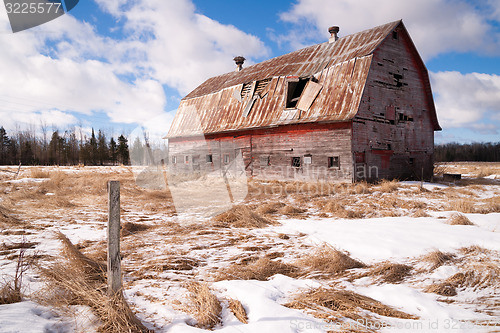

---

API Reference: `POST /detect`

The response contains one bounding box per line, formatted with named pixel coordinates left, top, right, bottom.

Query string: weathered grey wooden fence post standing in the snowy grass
left=108, top=181, right=122, bottom=295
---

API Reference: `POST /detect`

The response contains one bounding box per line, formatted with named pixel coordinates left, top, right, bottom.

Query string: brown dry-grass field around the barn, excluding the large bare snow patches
left=0, top=163, right=500, bottom=332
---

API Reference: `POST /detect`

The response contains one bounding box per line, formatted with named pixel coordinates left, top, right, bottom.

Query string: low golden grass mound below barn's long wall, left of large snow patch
left=213, top=205, right=274, bottom=228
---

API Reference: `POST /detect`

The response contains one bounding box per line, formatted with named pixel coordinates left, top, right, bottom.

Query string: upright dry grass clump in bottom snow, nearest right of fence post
left=181, top=282, right=222, bottom=329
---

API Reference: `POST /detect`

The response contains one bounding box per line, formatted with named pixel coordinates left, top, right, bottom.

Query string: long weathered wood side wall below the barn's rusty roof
left=169, top=123, right=353, bottom=182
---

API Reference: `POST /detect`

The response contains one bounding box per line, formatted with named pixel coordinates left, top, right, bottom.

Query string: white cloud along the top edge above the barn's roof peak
left=281, top=0, right=500, bottom=58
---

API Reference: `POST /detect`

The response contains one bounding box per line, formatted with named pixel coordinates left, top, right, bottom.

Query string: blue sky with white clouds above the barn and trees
left=0, top=0, right=500, bottom=143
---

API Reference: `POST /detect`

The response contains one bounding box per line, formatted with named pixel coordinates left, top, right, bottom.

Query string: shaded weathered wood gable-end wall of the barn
left=353, top=27, right=439, bottom=179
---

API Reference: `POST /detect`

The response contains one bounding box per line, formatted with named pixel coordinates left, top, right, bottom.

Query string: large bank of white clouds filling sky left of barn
left=0, top=0, right=267, bottom=131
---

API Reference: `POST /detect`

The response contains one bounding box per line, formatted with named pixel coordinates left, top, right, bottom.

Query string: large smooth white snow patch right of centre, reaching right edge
left=275, top=213, right=500, bottom=264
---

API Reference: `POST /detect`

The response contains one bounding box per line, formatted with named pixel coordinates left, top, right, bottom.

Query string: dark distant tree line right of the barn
left=434, top=142, right=500, bottom=162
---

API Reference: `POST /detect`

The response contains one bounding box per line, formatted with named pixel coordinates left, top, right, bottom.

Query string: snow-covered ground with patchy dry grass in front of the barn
left=0, top=167, right=500, bottom=332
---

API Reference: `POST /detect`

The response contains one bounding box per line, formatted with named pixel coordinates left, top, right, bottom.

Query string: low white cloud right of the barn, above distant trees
left=430, top=72, right=500, bottom=134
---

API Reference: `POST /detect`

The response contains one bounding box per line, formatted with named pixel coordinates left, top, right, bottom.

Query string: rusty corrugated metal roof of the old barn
left=167, top=21, right=402, bottom=138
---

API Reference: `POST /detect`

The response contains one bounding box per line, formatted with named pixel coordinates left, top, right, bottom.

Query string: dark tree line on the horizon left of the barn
left=0, top=126, right=130, bottom=165
